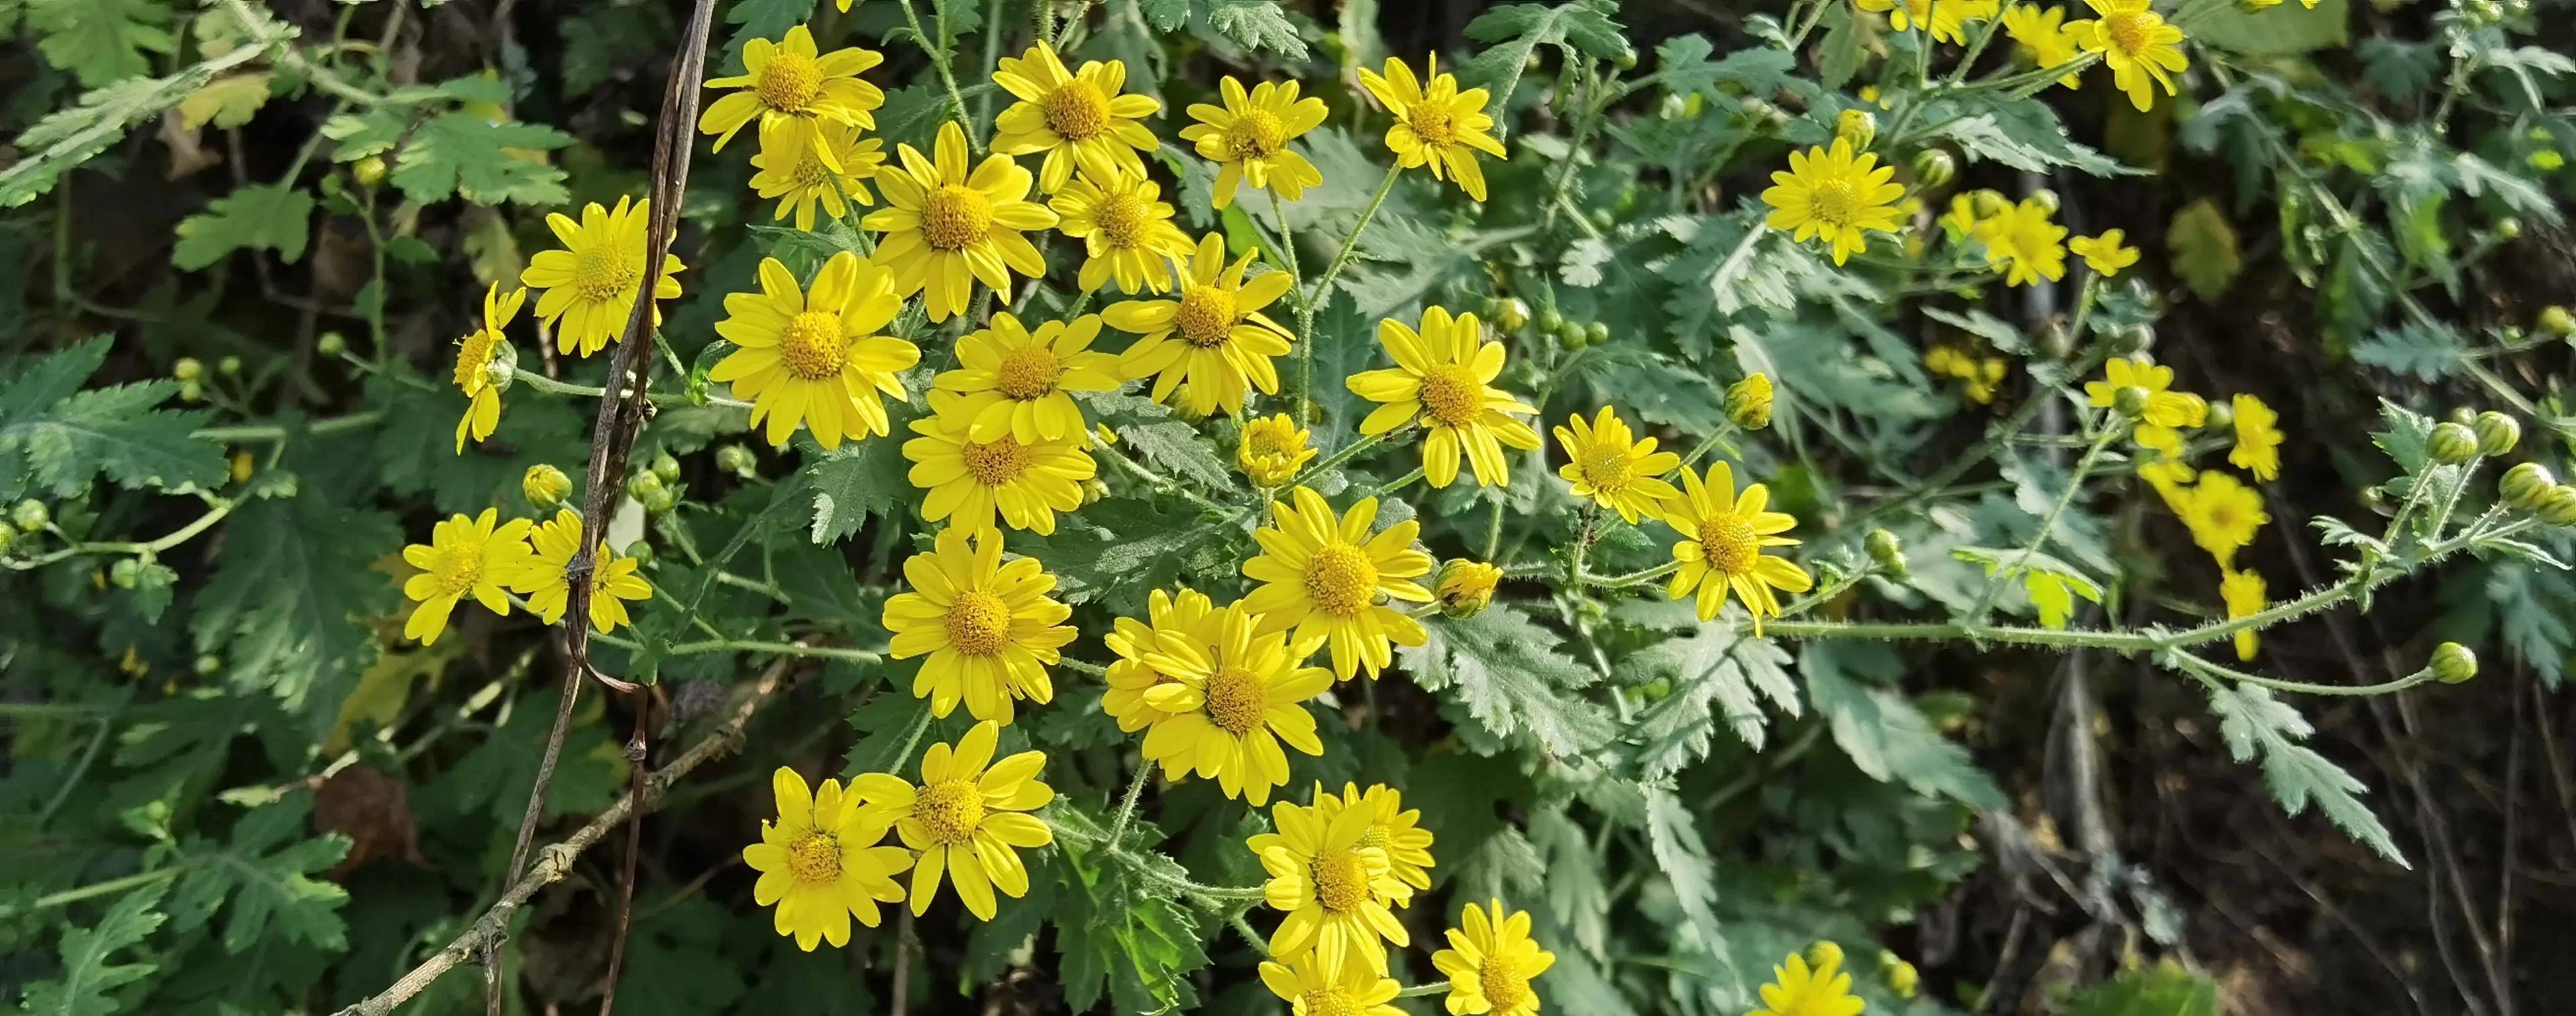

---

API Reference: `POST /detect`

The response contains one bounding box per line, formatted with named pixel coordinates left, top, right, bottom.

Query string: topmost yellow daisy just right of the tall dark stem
left=698, top=26, right=886, bottom=158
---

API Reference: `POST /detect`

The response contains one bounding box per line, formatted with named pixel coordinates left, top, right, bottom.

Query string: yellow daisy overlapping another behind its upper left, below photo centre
left=1144, top=603, right=1332, bottom=807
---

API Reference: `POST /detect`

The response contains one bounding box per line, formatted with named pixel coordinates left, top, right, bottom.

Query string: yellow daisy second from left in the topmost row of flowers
left=991, top=41, right=1162, bottom=195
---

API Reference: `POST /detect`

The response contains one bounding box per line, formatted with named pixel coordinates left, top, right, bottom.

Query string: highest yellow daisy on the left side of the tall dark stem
left=518, top=199, right=683, bottom=356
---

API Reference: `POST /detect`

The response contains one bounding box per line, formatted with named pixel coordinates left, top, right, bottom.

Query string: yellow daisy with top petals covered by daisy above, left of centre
left=904, top=392, right=1100, bottom=534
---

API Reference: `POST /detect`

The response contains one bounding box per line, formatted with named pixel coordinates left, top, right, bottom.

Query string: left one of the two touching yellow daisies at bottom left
left=742, top=766, right=912, bottom=952
